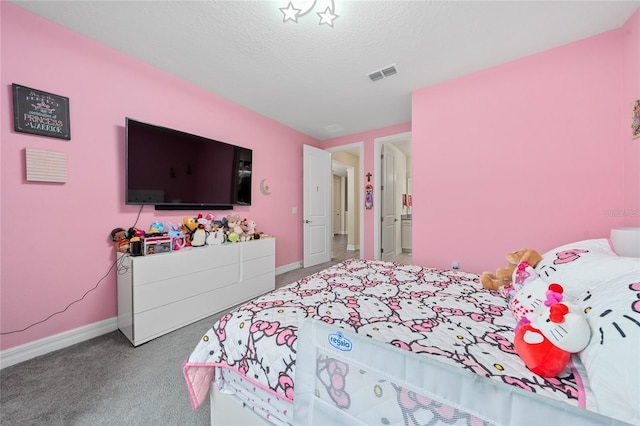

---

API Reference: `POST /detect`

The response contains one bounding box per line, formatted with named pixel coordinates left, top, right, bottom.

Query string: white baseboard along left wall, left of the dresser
left=0, top=317, right=118, bottom=369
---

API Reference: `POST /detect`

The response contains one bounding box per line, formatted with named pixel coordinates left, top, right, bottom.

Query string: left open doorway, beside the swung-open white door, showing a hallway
left=327, top=142, right=364, bottom=261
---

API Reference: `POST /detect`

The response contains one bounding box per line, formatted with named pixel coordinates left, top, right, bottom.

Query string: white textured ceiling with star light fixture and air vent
left=12, top=0, right=640, bottom=140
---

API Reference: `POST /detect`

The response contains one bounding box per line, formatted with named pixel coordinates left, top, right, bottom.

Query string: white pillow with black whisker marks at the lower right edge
left=576, top=272, right=640, bottom=424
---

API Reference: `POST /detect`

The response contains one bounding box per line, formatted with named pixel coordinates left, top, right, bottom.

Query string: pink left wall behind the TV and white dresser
left=0, top=2, right=317, bottom=349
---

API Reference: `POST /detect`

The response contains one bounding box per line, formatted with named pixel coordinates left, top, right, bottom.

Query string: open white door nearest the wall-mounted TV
left=302, top=145, right=331, bottom=268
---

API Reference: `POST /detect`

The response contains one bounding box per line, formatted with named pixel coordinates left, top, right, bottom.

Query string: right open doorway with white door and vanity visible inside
left=373, top=132, right=413, bottom=264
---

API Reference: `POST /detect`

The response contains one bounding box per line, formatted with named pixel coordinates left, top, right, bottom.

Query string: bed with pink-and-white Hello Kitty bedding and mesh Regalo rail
left=183, top=239, right=640, bottom=425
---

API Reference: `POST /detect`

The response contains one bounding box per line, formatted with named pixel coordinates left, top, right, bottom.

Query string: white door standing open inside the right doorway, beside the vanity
left=380, top=145, right=398, bottom=262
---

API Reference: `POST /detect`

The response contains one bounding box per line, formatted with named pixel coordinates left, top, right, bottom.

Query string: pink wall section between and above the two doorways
left=320, top=123, right=411, bottom=259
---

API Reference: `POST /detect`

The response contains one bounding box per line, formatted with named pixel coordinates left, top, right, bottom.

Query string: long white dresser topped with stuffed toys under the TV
left=118, top=238, right=276, bottom=346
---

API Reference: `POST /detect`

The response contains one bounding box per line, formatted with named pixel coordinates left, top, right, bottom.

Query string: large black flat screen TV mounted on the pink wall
left=125, top=117, right=253, bottom=210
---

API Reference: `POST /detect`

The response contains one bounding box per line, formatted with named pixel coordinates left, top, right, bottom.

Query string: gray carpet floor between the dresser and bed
left=0, top=315, right=219, bottom=426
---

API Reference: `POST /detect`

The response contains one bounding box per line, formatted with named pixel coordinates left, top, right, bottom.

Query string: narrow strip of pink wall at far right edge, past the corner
left=620, top=8, right=640, bottom=226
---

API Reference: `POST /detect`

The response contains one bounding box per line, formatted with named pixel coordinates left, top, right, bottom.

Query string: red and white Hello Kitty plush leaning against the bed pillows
left=509, top=262, right=591, bottom=377
